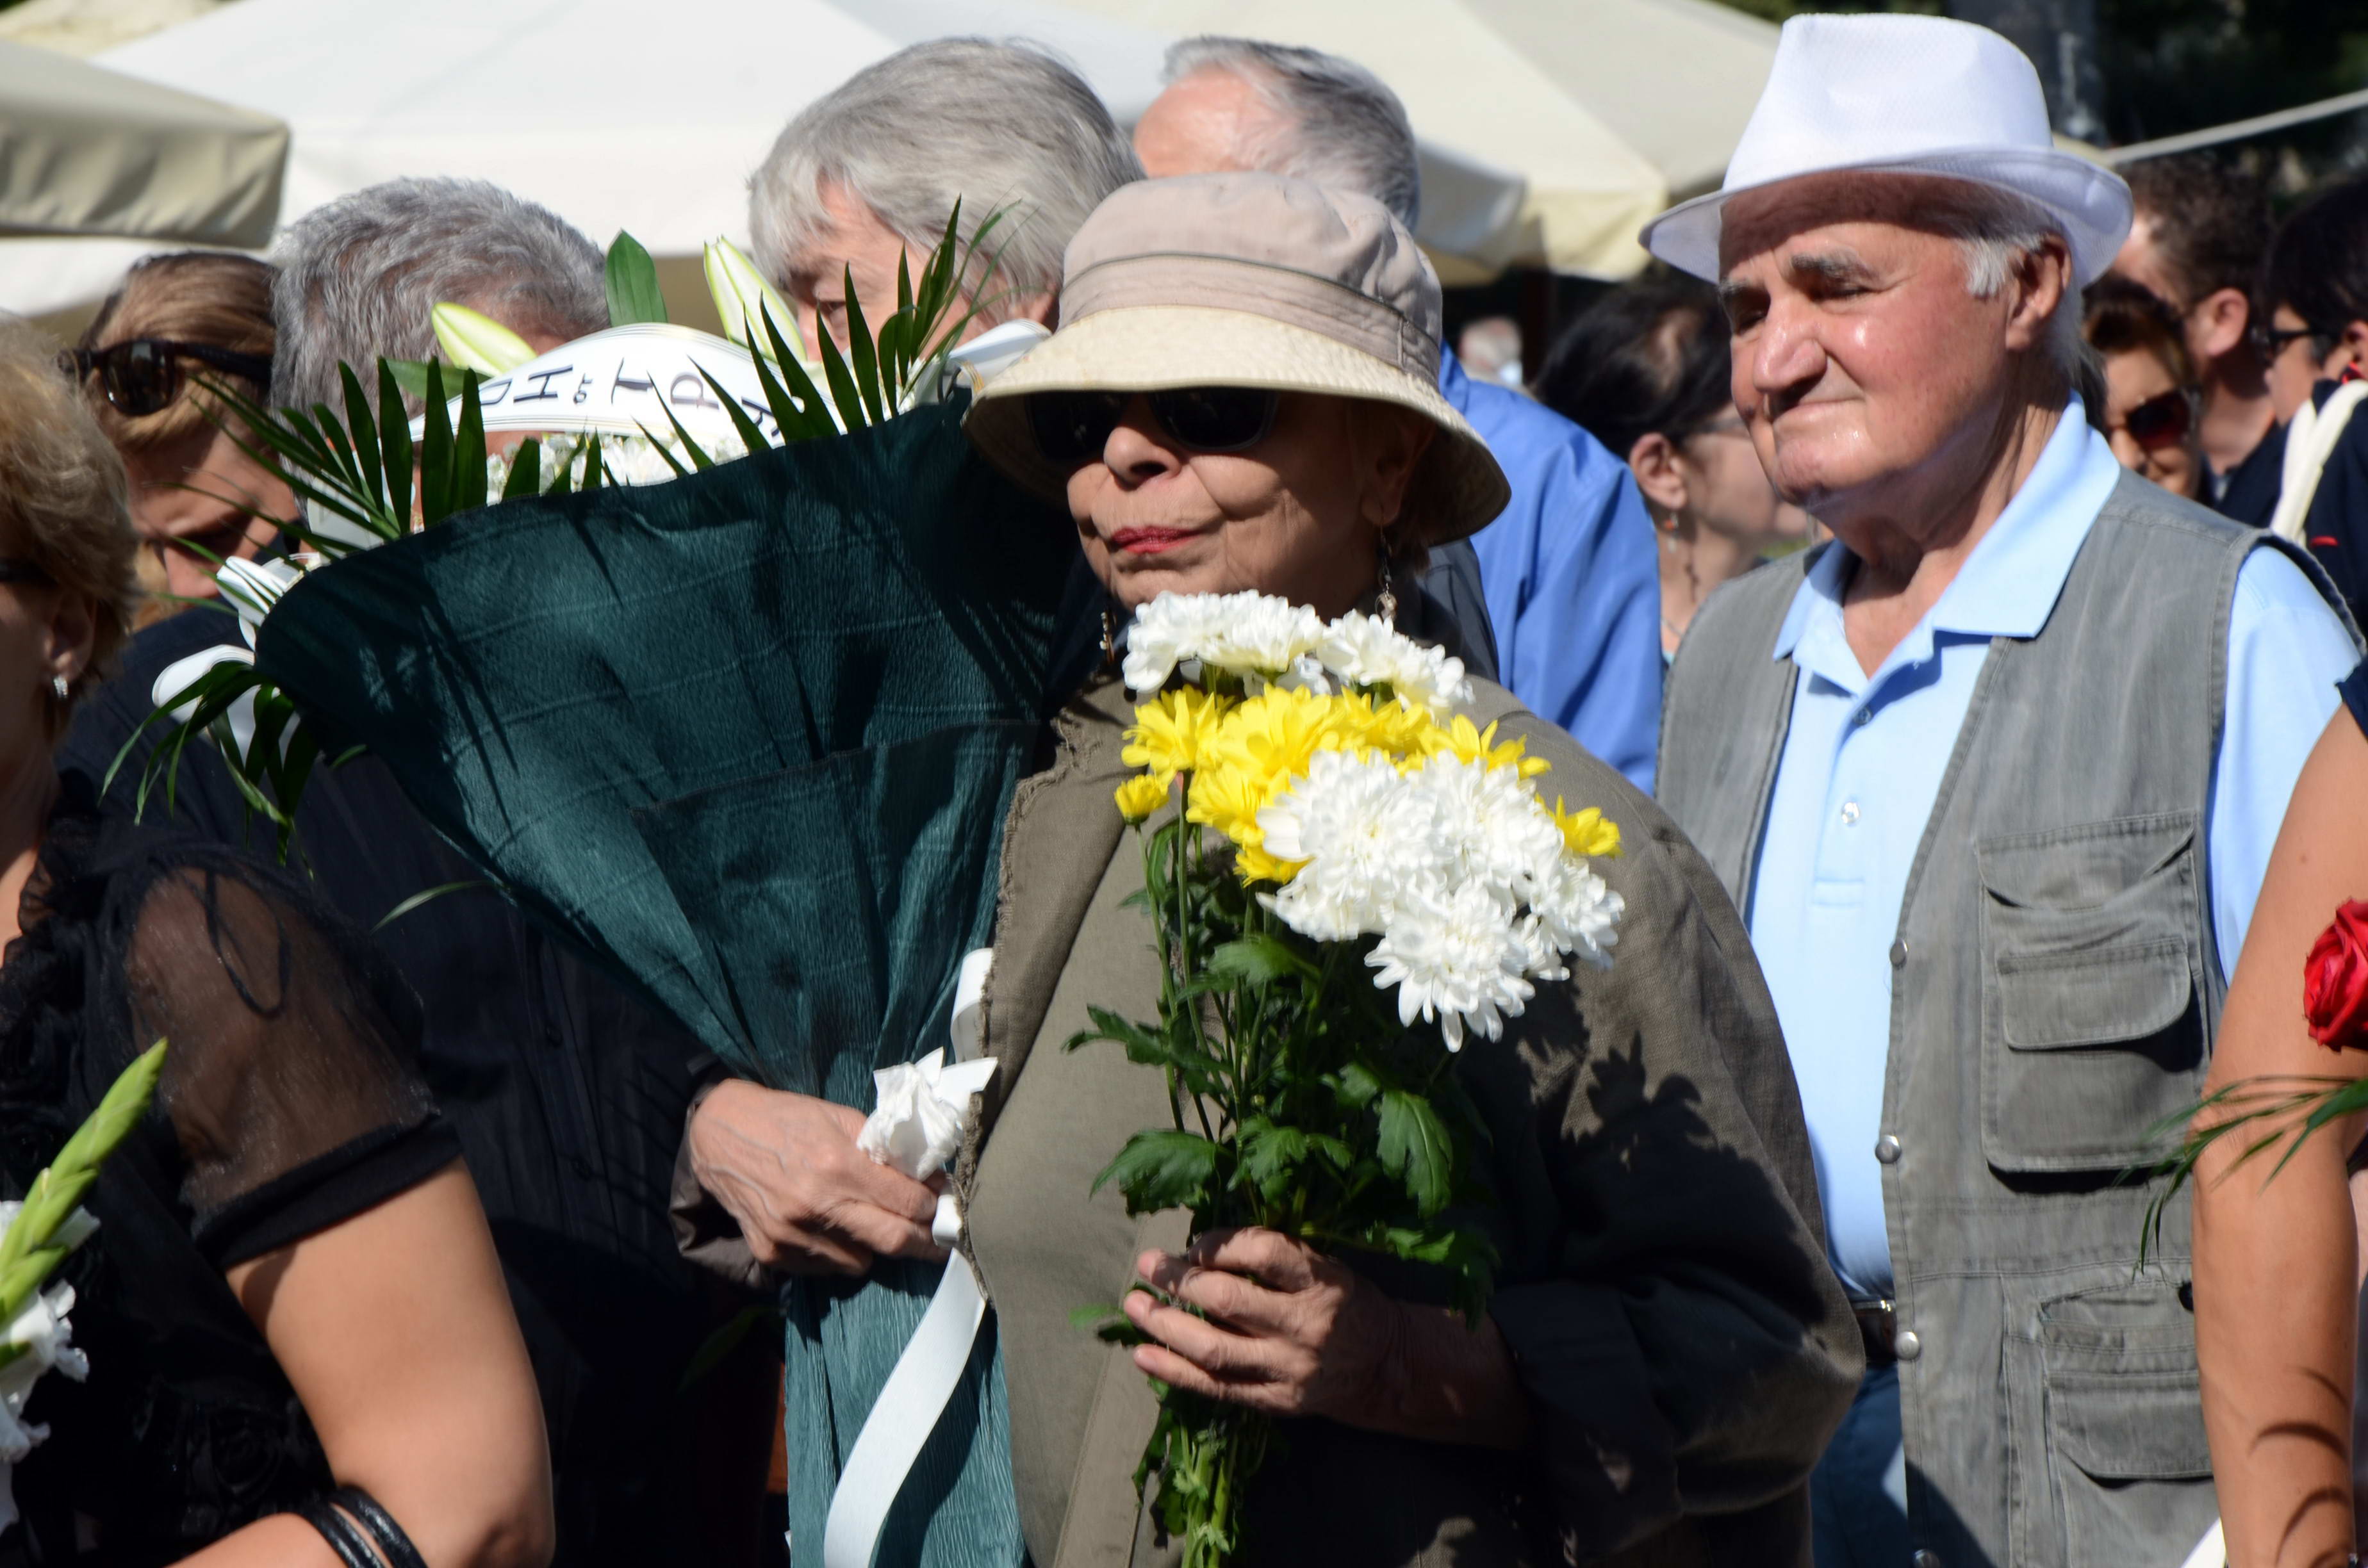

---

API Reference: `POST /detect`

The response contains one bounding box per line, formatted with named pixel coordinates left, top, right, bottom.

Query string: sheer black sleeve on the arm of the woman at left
left=123, top=865, right=459, bottom=1270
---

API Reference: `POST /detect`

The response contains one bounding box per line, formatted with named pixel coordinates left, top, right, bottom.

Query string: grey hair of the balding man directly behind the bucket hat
left=1165, top=35, right=1423, bottom=230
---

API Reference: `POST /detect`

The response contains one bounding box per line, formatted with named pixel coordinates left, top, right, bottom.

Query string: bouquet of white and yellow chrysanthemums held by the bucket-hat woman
left=1068, top=594, right=1622, bottom=1568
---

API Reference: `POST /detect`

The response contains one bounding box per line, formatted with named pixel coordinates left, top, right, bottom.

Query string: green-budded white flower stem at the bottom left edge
left=0, top=1040, right=163, bottom=1530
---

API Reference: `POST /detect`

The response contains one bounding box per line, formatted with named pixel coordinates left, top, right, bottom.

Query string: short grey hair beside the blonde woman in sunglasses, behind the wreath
left=272, top=180, right=609, bottom=414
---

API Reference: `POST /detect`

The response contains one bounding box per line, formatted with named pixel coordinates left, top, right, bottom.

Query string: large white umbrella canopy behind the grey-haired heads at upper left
left=0, top=0, right=1184, bottom=315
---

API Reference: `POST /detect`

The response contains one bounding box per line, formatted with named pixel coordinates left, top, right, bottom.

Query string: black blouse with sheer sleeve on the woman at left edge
left=0, top=777, right=459, bottom=1564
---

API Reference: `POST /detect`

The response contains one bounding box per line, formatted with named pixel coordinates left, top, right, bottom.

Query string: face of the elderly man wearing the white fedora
left=1719, top=176, right=2069, bottom=530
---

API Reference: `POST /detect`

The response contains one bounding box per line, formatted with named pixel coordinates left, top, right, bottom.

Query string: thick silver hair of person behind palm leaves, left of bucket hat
left=748, top=38, right=1144, bottom=320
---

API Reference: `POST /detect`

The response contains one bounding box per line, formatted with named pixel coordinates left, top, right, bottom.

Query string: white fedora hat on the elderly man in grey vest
left=1643, top=14, right=2131, bottom=286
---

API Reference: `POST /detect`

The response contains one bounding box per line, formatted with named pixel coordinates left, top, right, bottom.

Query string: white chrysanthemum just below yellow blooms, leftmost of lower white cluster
left=1258, top=751, right=1452, bottom=943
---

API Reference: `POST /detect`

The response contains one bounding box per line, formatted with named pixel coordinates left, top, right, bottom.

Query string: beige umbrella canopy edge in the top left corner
left=0, top=40, right=289, bottom=244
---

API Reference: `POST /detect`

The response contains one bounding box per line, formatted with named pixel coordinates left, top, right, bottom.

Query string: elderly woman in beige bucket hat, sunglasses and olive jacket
left=919, top=173, right=1859, bottom=1568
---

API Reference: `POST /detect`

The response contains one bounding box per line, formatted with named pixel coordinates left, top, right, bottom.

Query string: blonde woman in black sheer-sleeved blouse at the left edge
left=0, top=320, right=552, bottom=1568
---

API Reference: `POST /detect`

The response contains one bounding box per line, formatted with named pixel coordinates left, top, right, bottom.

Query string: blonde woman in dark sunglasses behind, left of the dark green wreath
left=59, top=251, right=296, bottom=625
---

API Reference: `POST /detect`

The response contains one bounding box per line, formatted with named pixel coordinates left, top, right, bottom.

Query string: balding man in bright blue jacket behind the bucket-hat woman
left=1134, top=38, right=1663, bottom=788
